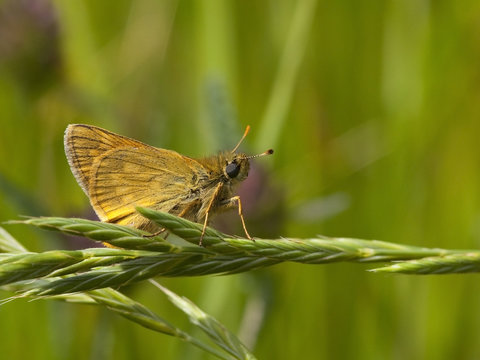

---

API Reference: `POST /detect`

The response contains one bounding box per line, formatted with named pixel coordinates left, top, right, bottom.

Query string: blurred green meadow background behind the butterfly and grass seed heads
left=0, top=0, right=480, bottom=359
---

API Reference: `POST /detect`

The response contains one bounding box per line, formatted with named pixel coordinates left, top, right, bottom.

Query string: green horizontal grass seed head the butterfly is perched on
left=0, top=208, right=480, bottom=296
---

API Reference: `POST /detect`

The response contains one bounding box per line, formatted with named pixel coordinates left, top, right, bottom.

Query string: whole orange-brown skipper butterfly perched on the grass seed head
left=64, top=124, right=273, bottom=245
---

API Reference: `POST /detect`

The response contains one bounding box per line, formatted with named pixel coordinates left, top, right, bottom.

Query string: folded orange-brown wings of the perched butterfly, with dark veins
left=65, top=125, right=207, bottom=230
